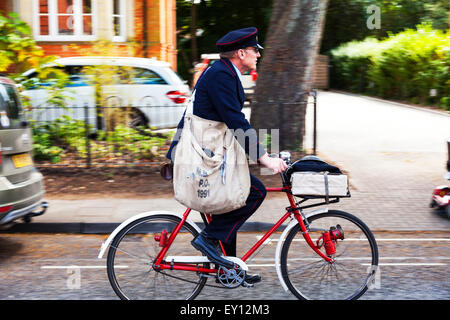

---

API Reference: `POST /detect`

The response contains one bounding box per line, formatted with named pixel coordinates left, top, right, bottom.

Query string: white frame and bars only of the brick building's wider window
left=33, top=0, right=97, bottom=41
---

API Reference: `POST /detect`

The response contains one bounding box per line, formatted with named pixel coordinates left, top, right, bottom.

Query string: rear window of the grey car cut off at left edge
left=0, top=84, right=23, bottom=129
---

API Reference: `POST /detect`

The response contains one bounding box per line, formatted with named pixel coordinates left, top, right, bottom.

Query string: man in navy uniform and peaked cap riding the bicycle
left=167, top=27, right=287, bottom=284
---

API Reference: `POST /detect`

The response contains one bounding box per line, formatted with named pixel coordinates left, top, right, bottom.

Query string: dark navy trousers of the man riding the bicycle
left=205, top=174, right=267, bottom=256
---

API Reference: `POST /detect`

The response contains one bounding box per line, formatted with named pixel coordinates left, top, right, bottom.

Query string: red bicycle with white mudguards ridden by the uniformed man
left=98, top=154, right=378, bottom=300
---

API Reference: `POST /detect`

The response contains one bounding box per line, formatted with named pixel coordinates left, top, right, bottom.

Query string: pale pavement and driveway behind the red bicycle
left=3, top=91, right=450, bottom=233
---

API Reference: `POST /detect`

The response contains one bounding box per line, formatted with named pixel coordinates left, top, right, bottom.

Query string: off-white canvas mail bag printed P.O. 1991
left=173, top=90, right=250, bottom=214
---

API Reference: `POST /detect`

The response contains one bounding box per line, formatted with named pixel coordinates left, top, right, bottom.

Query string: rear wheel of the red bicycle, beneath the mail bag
left=107, top=214, right=209, bottom=300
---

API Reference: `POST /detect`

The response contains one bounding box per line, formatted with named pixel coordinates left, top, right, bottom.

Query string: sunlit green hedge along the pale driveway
left=331, top=25, right=450, bottom=110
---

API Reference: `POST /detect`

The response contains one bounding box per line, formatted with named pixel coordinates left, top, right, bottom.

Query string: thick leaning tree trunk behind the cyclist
left=251, top=0, right=327, bottom=152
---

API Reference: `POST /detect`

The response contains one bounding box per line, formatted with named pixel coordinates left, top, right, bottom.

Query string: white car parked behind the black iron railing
left=22, top=56, right=190, bottom=128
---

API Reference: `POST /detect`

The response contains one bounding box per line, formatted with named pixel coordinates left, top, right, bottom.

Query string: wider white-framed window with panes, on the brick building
left=34, top=0, right=96, bottom=41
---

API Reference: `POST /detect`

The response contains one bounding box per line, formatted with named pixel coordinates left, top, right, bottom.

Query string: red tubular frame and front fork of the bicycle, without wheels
left=153, top=184, right=333, bottom=273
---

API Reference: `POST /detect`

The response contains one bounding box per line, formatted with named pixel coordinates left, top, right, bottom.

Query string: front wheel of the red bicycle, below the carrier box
left=281, top=210, right=378, bottom=300
